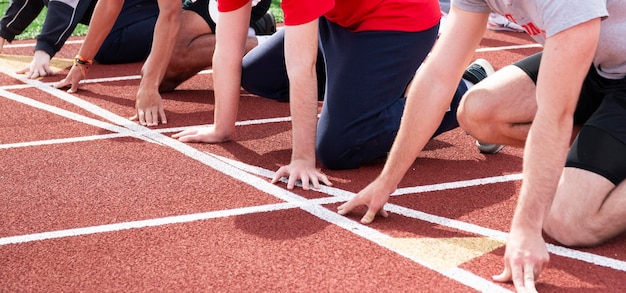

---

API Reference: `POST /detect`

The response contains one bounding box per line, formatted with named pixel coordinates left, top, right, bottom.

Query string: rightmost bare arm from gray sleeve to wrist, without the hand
left=512, top=19, right=600, bottom=234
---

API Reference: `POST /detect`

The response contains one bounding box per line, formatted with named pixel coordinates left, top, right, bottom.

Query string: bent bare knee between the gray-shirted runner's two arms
left=457, top=55, right=541, bottom=147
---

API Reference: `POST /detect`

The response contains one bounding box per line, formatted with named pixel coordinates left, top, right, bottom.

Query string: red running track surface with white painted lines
left=0, top=32, right=626, bottom=292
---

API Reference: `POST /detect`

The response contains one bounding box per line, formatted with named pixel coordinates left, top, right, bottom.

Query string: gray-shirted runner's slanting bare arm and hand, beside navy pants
left=339, top=6, right=488, bottom=223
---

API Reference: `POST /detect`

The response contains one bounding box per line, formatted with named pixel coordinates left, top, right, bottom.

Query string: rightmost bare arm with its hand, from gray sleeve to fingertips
left=495, top=19, right=600, bottom=292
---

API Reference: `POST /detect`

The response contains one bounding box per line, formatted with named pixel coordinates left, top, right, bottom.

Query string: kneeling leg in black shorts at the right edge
left=544, top=67, right=626, bottom=246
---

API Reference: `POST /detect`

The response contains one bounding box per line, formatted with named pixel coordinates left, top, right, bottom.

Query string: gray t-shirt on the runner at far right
left=452, top=0, right=626, bottom=79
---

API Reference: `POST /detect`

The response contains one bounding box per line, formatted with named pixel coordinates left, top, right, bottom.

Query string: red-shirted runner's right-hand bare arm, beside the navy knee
left=273, top=19, right=331, bottom=189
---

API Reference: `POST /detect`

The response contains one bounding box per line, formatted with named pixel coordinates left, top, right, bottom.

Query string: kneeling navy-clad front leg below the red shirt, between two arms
left=316, top=18, right=438, bottom=169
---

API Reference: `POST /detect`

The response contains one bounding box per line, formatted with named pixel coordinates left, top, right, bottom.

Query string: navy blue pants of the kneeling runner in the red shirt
left=242, top=17, right=467, bottom=169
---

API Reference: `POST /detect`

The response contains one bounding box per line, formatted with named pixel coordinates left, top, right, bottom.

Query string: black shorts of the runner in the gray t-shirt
left=514, top=53, right=626, bottom=185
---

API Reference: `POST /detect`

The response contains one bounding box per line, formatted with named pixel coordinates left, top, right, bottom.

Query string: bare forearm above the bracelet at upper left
left=78, top=0, right=124, bottom=60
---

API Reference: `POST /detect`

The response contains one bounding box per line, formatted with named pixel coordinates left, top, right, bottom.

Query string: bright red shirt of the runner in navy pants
left=217, top=0, right=441, bottom=32
